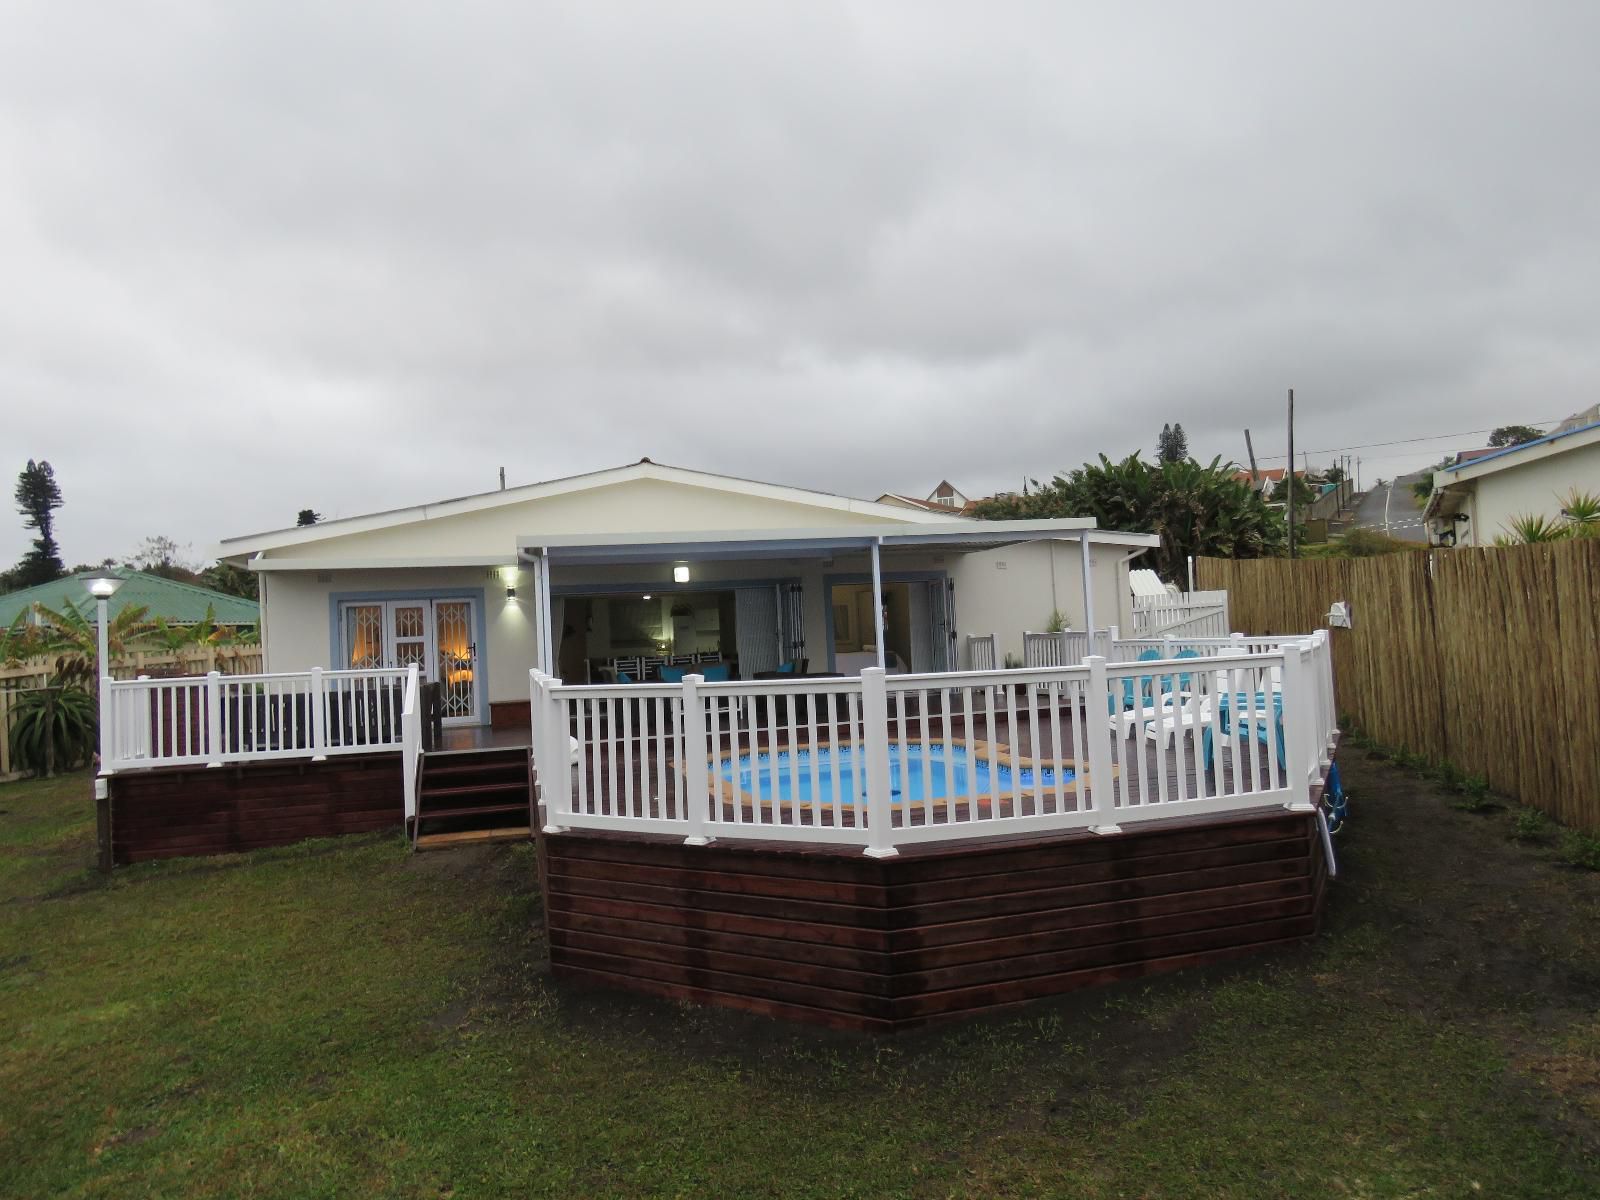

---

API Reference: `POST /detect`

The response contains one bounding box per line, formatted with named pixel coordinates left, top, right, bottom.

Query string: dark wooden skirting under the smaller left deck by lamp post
left=102, top=754, right=405, bottom=866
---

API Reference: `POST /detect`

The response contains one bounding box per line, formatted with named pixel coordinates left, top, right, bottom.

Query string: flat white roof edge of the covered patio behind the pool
left=517, top=517, right=1160, bottom=565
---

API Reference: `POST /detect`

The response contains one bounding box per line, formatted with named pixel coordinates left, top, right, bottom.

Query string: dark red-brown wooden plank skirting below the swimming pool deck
left=539, top=810, right=1326, bottom=1032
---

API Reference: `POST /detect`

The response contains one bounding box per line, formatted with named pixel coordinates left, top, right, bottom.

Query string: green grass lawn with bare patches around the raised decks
left=0, top=761, right=1600, bottom=1197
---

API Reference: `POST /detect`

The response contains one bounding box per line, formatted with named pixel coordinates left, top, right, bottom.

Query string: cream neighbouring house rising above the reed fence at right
left=1422, top=421, right=1600, bottom=546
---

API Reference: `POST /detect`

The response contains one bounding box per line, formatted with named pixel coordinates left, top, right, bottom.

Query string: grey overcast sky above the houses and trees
left=0, top=0, right=1600, bottom=563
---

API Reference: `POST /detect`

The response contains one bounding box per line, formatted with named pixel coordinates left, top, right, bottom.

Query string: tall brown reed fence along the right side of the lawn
left=1197, top=539, right=1600, bottom=830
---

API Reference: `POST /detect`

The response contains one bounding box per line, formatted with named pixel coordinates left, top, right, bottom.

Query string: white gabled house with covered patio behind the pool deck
left=222, top=459, right=1155, bottom=725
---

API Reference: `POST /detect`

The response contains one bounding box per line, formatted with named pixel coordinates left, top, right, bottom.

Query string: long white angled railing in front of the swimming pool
left=530, top=634, right=1334, bottom=856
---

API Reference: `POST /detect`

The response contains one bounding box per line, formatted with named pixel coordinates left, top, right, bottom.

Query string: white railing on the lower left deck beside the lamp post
left=101, top=667, right=414, bottom=771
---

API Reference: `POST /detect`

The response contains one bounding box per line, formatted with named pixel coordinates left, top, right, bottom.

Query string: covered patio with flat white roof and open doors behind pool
left=517, top=518, right=1155, bottom=683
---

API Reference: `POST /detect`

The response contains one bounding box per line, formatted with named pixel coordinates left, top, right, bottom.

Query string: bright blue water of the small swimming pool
left=718, top=742, right=1075, bottom=805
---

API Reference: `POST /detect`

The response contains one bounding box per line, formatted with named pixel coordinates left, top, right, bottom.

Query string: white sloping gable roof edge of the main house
left=219, top=458, right=950, bottom=560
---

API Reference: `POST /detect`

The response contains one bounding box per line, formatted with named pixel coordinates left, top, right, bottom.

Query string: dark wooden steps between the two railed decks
left=411, top=747, right=533, bottom=850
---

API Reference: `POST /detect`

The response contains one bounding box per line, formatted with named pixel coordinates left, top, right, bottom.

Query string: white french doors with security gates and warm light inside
left=339, top=597, right=483, bottom=725
